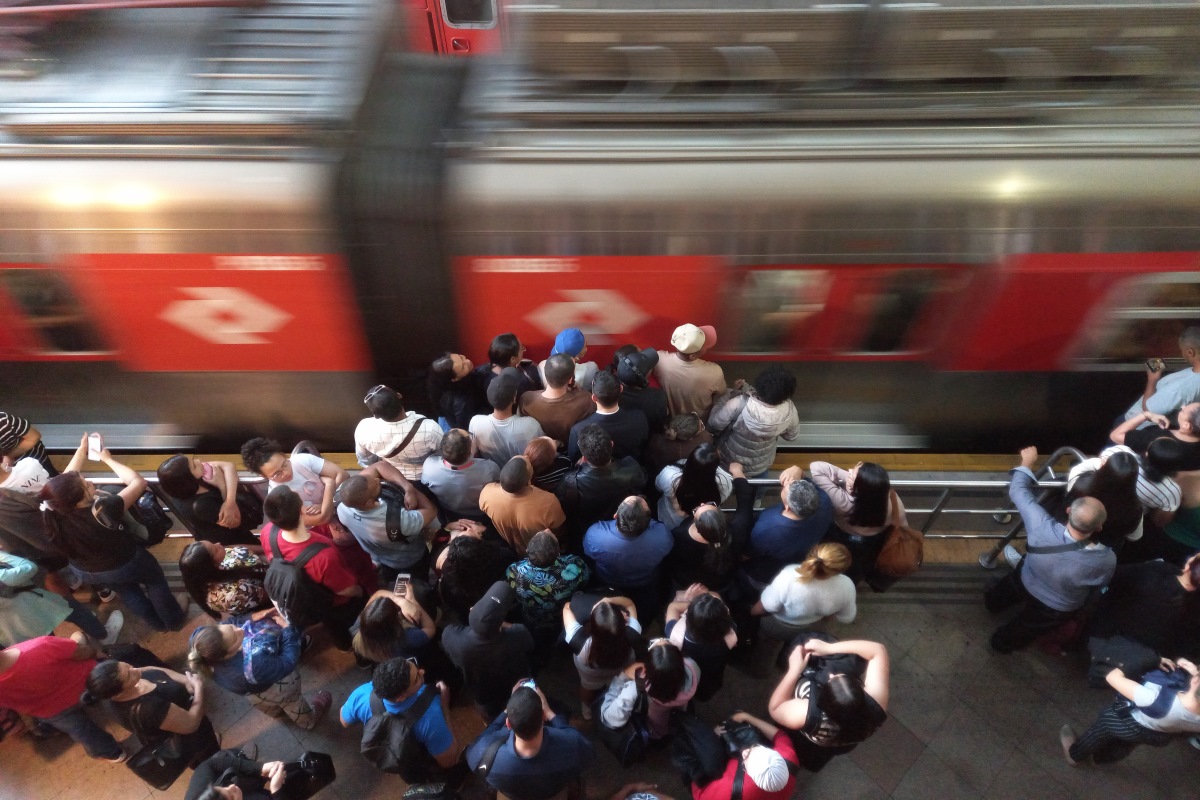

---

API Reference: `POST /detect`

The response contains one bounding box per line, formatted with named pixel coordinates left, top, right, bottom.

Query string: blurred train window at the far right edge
left=1079, top=272, right=1200, bottom=368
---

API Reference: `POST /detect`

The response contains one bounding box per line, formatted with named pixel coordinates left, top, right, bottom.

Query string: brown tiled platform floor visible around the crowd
left=0, top=540, right=1200, bottom=800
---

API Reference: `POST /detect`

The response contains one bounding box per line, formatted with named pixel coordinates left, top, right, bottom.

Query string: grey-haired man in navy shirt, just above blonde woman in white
left=742, top=467, right=833, bottom=591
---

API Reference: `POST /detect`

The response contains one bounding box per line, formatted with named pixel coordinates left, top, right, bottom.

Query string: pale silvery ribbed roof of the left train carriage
left=0, top=0, right=395, bottom=154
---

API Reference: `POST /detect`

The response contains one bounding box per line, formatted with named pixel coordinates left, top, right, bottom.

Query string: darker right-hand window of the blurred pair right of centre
left=853, top=269, right=938, bottom=353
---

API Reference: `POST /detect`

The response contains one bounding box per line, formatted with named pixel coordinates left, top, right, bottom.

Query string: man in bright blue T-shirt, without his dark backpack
left=341, top=658, right=458, bottom=769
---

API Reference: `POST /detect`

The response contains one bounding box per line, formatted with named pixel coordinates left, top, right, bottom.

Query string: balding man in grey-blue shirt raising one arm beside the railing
left=984, top=447, right=1117, bottom=652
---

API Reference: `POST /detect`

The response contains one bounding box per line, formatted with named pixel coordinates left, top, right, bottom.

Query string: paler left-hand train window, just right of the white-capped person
left=722, top=270, right=833, bottom=353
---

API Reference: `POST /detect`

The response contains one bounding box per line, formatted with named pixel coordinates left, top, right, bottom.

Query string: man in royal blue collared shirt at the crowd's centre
left=583, top=494, right=674, bottom=620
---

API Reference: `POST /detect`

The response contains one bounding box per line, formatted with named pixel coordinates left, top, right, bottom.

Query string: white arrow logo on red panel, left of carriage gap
left=160, top=287, right=292, bottom=344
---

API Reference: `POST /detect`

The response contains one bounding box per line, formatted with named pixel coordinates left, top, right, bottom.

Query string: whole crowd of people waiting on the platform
left=0, top=324, right=1200, bottom=800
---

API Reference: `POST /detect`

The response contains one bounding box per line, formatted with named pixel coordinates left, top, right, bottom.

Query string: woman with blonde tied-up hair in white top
left=750, top=543, right=858, bottom=639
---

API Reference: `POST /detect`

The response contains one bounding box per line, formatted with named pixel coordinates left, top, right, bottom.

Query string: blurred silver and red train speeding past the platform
left=0, top=0, right=1200, bottom=451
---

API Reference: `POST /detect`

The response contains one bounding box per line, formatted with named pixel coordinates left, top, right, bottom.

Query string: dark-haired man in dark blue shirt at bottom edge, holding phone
left=467, top=684, right=595, bottom=800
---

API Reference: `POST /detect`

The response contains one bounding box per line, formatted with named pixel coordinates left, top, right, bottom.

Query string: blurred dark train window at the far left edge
left=0, top=269, right=108, bottom=354
